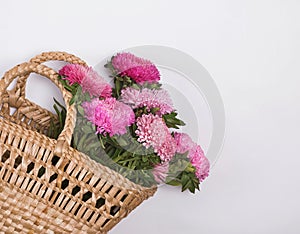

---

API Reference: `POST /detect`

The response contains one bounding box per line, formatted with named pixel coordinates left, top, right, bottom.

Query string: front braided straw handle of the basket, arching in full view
left=0, top=63, right=76, bottom=157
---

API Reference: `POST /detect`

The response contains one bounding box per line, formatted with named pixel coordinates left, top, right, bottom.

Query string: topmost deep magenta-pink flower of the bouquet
left=112, top=53, right=160, bottom=84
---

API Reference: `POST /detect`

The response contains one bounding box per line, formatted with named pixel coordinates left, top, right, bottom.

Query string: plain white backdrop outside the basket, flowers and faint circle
left=0, top=0, right=300, bottom=234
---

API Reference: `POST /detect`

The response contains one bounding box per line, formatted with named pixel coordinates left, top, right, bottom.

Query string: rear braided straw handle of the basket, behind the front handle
left=15, top=51, right=87, bottom=97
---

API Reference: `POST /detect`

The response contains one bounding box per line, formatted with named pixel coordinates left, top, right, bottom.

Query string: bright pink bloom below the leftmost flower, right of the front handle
left=82, top=98, right=135, bottom=136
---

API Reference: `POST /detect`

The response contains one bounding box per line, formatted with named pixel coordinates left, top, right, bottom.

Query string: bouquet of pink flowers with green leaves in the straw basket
left=50, top=53, right=210, bottom=193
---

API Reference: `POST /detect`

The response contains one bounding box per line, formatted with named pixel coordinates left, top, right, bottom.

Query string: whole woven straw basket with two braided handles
left=0, top=52, right=156, bottom=233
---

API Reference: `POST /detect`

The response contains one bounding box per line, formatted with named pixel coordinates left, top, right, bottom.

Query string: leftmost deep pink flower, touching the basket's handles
left=59, top=64, right=112, bottom=97
